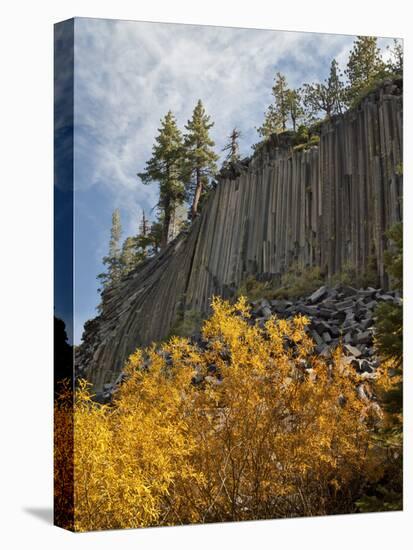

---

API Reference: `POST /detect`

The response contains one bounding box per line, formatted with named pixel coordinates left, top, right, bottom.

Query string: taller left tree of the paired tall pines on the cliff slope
left=138, top=111, right=184, bottom=248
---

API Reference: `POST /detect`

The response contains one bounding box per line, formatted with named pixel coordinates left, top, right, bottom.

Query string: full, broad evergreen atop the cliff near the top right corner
left=345, top=36, right=386, bottom=105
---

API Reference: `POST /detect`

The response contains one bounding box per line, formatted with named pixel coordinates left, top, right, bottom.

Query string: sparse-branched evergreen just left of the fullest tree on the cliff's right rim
left=303, top=59, right=344, bottom=118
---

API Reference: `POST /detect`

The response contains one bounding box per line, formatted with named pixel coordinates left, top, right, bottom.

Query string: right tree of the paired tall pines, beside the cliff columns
left=184, top=100, right=218, bottom=218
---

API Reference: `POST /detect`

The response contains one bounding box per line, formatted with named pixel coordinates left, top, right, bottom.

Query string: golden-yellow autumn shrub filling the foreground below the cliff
left=56, top=298, right=384, bottom=530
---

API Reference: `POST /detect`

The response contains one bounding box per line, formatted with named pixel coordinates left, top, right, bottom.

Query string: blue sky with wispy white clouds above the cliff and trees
left=73, top=18, right=391, bottom=344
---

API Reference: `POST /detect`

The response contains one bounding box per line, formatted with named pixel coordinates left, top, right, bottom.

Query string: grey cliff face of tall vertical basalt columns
left=77, top=83, right=403, bottom=390
